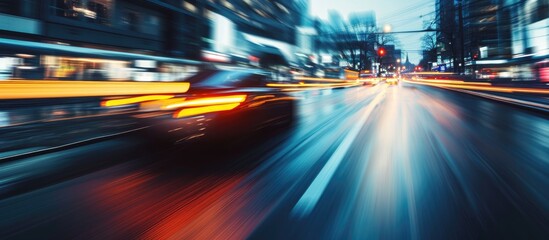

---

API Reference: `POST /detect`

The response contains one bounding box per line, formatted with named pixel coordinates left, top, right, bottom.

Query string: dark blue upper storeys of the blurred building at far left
left=0, top=0, right=207, bottom=58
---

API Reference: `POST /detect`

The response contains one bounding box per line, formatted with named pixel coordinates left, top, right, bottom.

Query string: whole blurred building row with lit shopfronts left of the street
left=0, top=0, right=302, bottom=80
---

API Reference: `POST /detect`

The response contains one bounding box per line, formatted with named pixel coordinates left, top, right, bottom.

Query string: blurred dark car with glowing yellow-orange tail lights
left=140, top=69, right=295, bottom=142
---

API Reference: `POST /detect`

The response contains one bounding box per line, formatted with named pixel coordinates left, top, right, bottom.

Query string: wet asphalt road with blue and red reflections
left=0, top=83, right=549, bottom=239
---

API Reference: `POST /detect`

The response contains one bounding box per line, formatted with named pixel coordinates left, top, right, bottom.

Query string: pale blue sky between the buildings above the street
left=309, top=0, right=435, bottom=64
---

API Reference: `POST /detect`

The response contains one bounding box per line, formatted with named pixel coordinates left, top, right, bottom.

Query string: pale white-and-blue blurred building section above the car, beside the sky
left=204, top=0, right=300, bottom=66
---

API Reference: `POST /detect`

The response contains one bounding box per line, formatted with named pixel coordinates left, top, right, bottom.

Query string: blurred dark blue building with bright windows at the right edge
left=436, top=0, right=549, bottom=80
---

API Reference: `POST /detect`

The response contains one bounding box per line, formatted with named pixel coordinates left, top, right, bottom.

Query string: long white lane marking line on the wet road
left=291, top=88, right=387, bottom=217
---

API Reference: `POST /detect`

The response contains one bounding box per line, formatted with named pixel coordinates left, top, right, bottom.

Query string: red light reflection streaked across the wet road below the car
left=89, top=169, right=257, bottom=239
